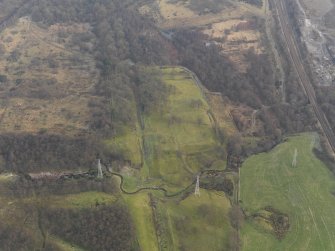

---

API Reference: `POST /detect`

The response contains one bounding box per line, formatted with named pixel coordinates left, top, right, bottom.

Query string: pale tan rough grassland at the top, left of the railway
left=139, top=0, right=265, bottom=72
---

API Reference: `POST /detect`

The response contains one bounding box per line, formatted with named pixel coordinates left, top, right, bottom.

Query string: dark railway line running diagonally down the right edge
left=271, top=0, right=335, bottom=152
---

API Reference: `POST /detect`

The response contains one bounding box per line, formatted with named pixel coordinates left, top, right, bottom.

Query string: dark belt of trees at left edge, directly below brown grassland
left=0, top=134, right=112, bottom=172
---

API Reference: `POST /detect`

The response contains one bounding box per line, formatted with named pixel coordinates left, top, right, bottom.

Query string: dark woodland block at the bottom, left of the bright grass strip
left=41, top=204, right=136, bottom=251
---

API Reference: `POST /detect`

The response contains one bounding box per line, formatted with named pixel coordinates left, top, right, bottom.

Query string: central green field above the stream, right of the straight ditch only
left=144, top=67, right=216, bottom=187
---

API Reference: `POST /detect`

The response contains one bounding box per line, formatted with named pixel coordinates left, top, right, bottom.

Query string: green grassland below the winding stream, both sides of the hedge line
left=123, top=190, right=232, bottom=251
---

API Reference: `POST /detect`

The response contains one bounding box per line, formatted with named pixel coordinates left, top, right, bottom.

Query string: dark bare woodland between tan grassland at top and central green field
left=174, top=31, right=278, bottom=108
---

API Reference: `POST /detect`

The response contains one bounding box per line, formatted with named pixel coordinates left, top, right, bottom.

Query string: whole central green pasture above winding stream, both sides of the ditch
left=113, top=67, right=225, bottom=192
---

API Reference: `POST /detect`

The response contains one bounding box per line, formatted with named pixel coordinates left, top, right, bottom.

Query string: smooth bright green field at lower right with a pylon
left=241, top=134, right=335, bottom=250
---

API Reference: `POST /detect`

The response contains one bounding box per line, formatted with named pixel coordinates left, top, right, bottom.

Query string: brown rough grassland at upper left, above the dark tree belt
left=0, top=18, right=98, bottom=134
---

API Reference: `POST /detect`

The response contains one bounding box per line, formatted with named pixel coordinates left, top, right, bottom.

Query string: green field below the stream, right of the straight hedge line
left=163, top=190, right=231, bottom=251
